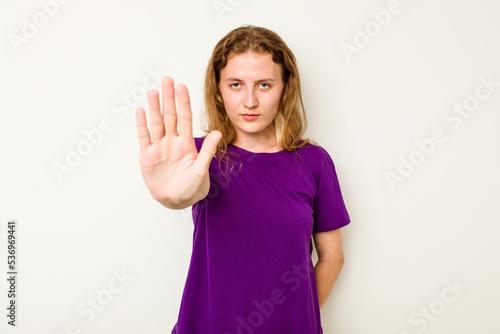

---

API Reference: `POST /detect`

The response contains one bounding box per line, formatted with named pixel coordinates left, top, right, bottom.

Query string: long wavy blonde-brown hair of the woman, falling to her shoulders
left=203, top=25, right=317, bottom=176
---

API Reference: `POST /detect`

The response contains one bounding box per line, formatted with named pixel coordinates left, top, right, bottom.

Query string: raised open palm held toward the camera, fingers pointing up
left=136, top=77, right=222, bottom=209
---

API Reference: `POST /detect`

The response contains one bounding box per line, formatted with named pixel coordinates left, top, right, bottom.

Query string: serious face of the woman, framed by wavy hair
left=219, top=52, right=284, bottom=142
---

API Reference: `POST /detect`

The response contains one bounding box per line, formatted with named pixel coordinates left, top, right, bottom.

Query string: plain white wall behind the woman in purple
left=0, top=0, right=500, bottom=334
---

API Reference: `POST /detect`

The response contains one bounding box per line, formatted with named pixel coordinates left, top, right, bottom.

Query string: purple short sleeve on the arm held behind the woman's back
left=313, top=147, right=350, bottom=233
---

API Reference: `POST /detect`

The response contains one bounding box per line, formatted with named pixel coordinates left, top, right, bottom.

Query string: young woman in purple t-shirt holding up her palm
left=136, top=26, right=350, bottom=334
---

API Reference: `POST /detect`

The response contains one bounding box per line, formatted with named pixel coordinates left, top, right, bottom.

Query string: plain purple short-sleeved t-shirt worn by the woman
left=172, top=137, right=350, bottom=334
